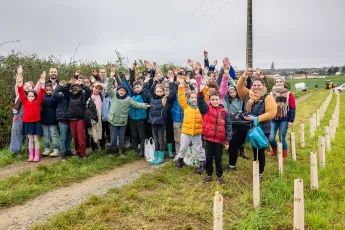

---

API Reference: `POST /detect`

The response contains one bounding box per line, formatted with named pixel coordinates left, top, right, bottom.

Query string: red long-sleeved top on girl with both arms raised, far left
left=18, top=86, right=44, bottom=122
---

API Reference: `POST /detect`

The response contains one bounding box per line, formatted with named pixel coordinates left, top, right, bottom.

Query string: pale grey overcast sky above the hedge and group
left=0, top=0, right=345, bottom=68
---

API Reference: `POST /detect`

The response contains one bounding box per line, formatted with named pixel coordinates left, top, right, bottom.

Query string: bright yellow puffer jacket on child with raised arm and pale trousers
left=178, top=85, right=202, bottom=136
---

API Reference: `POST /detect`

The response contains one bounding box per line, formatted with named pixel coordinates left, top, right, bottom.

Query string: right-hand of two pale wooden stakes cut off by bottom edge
left=293, top=179, right=304, bottom=230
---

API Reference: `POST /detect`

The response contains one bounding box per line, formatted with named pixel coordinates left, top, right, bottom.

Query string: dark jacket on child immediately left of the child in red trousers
left=53, top=85, right=69, bottom=121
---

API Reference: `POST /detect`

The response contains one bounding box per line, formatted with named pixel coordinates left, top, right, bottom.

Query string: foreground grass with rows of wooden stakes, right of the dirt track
left=33, top=91, right=345, bottom=229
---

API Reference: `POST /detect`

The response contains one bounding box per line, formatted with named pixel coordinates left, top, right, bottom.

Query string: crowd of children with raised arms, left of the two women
left=11, top=52, right=292, bottom=184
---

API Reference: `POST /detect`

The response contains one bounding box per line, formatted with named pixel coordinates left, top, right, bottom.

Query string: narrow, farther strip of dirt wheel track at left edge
left=0, top=157, right=61, bottom=181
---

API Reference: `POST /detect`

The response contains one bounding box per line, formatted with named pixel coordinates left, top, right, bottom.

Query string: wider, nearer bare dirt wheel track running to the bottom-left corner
left=0, top=160, right=164, bottom=229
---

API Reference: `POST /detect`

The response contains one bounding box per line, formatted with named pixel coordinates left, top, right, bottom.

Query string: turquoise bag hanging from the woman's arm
left=245, top=117, right=268, bottom=149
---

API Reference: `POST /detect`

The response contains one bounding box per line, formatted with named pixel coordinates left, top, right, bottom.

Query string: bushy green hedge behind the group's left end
left=0, top=51, right=113, bottom=148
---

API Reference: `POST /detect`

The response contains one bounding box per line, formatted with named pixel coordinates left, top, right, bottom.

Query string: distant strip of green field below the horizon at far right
left=287, top=76, right=345, bottom=93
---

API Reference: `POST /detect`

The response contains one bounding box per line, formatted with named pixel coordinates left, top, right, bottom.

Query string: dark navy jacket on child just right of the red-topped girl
left=41, top=95, right=57, bottom=125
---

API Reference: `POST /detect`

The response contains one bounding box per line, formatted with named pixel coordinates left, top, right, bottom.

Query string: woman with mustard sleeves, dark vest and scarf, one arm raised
left=237, top=70, right=277, bottom=181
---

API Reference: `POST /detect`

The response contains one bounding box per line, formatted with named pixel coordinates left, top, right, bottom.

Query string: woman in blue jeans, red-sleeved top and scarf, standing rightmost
left=267, top=77, right=296, bottom=162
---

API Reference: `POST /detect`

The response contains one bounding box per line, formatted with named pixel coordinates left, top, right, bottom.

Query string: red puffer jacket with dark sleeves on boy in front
left=198, top=93, right=232, bottom=144
